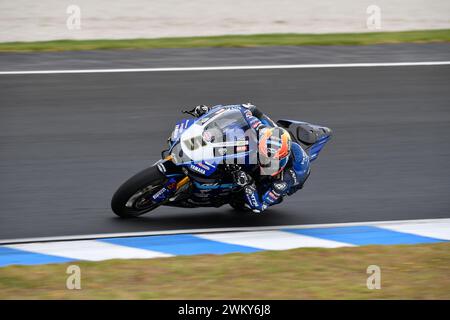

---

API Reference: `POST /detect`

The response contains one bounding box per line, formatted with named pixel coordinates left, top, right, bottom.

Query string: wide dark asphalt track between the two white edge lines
left=0, top=47, right=450, bottom=239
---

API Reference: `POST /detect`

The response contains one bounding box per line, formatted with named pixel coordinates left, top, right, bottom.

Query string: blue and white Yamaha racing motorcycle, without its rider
left=111, top=105, right=331, bottom=218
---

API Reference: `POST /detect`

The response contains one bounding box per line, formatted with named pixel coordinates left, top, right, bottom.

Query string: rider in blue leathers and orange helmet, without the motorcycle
left=188, top=104, right=310, bottom=213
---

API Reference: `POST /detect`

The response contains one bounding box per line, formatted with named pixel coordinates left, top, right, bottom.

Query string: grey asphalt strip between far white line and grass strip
left=0, top=43, right=450, bottom=71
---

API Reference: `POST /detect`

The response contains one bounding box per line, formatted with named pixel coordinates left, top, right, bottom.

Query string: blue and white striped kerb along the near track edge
left=0, top=219, right=450, bottom=266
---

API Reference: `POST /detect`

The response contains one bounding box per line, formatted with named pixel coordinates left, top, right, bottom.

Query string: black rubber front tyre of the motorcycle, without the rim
left=111, top=166, right=167, bottom=218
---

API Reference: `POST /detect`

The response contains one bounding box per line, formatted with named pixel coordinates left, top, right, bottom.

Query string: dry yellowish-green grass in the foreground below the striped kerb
left=0, top=243, right=450, bottom=299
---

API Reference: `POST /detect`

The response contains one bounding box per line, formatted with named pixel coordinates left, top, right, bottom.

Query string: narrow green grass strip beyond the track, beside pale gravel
left=0, top=29, right=450, bottom=52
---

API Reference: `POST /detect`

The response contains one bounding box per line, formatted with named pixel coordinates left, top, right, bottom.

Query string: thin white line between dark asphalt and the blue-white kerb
left=0, top=218, right=450, bottom=244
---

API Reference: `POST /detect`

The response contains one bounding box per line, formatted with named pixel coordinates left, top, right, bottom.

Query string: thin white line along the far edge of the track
left=0, top=61, right=450, bottom=75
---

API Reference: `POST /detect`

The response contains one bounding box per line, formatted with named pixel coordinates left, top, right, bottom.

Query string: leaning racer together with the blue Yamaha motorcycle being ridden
left=111, top=104, right=332, bottom=218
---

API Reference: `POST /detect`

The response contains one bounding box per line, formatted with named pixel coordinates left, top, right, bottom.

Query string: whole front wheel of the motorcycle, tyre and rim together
left=111, top=166, right=167, bottom=218
